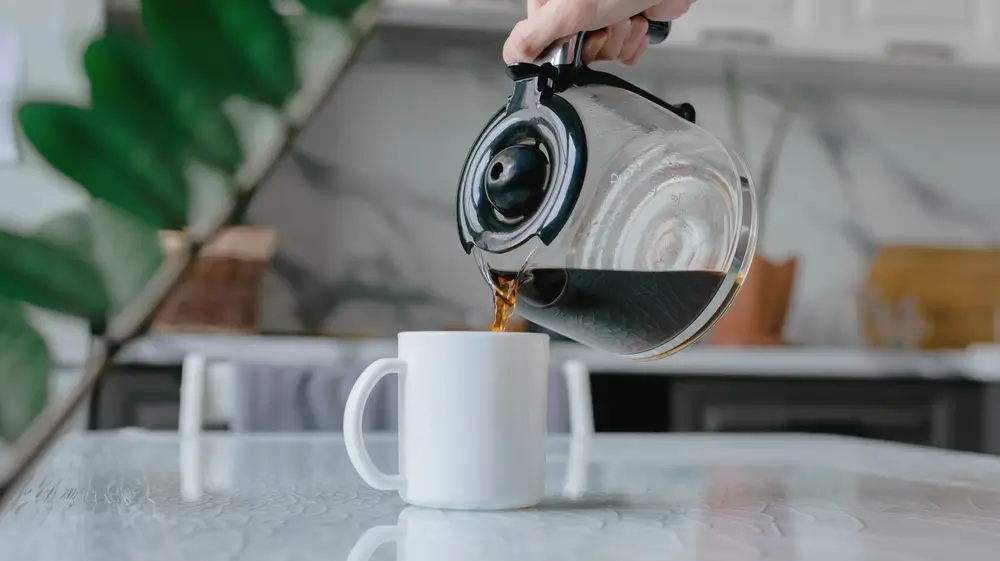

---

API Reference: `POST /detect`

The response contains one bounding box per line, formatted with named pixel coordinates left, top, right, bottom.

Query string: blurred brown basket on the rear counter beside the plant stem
left=152, top=227, right=277, bottom=333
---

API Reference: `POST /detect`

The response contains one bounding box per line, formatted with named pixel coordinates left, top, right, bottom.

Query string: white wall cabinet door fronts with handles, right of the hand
left=675, top=0, right=1000, bottom=64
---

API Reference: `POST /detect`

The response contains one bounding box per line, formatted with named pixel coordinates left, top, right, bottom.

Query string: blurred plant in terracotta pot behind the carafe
left=712, top=60, right=801, bottom=345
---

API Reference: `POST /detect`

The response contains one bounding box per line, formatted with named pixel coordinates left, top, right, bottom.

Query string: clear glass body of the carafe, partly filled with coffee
left=479, top=84, right=757, bottom=359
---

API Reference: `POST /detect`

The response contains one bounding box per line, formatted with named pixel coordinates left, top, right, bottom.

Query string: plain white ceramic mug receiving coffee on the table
left=344, top=331, right=549, bottom=510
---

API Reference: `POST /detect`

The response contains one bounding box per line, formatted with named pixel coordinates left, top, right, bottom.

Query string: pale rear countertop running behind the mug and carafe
left=103, top=335, right=1000, bottom=382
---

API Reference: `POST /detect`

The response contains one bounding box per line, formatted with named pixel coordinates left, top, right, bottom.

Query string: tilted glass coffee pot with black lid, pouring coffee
left=457, top=22, right=757, bottom=359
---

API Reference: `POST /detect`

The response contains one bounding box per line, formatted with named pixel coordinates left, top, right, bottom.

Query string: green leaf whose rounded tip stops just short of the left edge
left=18, top=102, right=188, bottom=228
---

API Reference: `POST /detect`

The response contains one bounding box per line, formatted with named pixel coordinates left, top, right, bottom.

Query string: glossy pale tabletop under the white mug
left=0, top=430, right=1000, bottom=561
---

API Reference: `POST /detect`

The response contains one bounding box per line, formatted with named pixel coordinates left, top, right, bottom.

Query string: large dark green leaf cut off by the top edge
left=142, top=0, right=298, bottom=108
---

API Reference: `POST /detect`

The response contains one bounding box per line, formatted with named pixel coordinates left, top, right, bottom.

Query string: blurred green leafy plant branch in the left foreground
left=0, top=0, right=376, bottom=503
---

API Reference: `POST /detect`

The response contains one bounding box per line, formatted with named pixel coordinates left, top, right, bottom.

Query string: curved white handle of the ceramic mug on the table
left=344, top=358, right=406, bottom=491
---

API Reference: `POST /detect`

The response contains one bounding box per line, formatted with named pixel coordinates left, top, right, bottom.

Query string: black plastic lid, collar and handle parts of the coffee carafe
left=457, top=22, right=694, bottom=253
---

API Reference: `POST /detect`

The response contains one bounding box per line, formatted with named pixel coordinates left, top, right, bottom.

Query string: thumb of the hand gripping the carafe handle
left=503, top=0, right=596, bottom=64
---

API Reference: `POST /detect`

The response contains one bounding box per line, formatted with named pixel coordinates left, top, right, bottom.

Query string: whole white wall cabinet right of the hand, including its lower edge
left=632, top=0, right=1000, bottom=95
